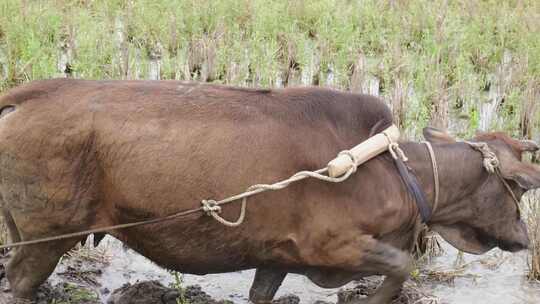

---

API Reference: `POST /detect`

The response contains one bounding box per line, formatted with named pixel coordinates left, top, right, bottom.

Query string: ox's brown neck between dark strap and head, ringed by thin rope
left=401, top=142, right=487, bottom=223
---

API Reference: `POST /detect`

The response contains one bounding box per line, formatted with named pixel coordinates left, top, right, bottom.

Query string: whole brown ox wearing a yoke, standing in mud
left=0, top=80, right=540, bottom=304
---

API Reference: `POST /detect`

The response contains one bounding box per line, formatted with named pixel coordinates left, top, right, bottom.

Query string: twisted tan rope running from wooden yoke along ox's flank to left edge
left=0, top=151, right=357, bottom=249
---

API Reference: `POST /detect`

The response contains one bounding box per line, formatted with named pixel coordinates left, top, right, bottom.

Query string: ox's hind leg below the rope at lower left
left=6, top=239, right=80, bottom=299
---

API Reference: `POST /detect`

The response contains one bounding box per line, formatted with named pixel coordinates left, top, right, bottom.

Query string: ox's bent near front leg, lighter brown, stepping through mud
left=300, top=229, right=412, bottom=304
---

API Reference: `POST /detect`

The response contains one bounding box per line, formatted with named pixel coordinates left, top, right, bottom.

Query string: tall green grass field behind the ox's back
left=0, top=0, right=540, bottom=137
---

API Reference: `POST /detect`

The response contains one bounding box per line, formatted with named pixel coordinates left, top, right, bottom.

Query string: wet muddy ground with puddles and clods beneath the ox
left=0, top=238, right=540, bottom=304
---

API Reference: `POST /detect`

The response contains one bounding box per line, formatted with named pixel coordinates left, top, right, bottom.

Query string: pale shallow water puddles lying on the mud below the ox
left=47, top=238, right=540, bottom=304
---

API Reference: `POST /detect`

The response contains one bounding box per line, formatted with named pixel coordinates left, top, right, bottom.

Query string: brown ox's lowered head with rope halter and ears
left=424, top=128, right=540, bottom=254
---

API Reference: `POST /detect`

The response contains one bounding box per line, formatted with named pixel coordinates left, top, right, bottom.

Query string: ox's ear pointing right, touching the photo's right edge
left=501, top=160, right=540, bottom=190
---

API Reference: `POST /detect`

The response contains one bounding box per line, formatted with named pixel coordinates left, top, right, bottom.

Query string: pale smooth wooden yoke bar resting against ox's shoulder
left=328, top=125, right=399, bottom=177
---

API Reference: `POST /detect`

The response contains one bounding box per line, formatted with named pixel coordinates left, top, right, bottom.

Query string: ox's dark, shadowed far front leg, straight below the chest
left=249, top=268, right=287, bottom=303
